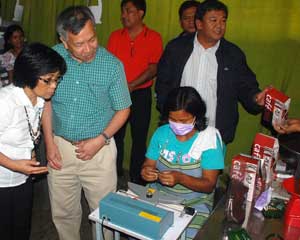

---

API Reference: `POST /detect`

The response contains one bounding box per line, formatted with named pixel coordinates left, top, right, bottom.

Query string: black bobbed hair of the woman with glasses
left=13, top=43, right=67, bottom=89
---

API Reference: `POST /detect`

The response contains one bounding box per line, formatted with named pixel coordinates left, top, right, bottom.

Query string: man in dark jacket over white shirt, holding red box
left=155, top=1, right=266, bottom=144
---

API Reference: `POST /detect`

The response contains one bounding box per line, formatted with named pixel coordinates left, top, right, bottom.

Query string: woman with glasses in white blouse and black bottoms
left=0, top=43, right=66, bottom=240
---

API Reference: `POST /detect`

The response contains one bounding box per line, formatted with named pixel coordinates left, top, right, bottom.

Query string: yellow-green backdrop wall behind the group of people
left=1, top=0, right=300, bottom=169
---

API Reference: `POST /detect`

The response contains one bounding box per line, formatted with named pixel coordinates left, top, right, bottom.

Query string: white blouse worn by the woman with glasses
left=0, top=85, right=44, bottom=187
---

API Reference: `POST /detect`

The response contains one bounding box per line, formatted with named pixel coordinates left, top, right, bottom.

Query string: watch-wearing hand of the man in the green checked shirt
left=73, top=136, right=105, bottom=161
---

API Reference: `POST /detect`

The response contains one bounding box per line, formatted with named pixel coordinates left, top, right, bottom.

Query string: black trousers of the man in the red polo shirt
left=114, top=87, right=152, bottom=184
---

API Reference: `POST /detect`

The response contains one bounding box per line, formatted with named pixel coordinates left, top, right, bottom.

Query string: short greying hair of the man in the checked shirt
left=56, top=6, right=96, bottom=40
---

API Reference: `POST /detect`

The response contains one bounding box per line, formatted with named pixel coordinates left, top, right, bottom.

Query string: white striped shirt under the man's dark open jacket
left=180, top=34, right=220, bottom=127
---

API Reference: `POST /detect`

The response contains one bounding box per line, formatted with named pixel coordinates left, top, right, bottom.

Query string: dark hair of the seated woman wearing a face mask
left=160, top=87, right=207, bottom=131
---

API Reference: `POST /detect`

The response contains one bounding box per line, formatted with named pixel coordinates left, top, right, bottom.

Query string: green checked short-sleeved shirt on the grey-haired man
left=52, top=44, right=131, bottom=141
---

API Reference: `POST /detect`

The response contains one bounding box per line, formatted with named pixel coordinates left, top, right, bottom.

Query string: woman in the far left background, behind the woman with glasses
left=0, top=24, right=24, bottom=86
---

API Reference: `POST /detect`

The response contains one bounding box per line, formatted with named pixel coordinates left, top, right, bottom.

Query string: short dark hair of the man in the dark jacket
left=195, top=0, right=228, bottom=21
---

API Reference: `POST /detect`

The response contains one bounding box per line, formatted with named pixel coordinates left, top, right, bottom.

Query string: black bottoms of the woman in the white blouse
left=0, top=177, right=32, bottom=240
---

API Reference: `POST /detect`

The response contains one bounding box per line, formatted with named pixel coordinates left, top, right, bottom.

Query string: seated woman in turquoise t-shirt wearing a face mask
left=141, top=87, right=224, bottom=239
